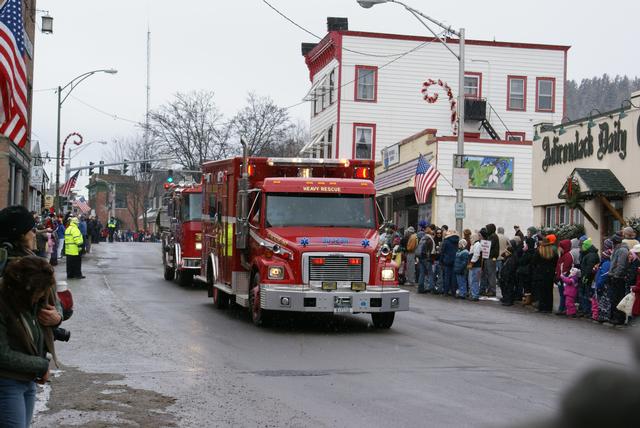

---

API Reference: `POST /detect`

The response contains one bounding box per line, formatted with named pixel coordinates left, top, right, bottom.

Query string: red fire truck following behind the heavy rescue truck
left=162, top=184, right=202, bottom=287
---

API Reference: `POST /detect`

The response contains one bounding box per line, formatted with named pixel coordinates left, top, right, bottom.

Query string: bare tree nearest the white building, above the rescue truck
left=232, top=92, right=292, bottom=156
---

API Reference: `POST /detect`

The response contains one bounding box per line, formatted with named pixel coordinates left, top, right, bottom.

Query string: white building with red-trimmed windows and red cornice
left=302, top=18, right=569, bottom=159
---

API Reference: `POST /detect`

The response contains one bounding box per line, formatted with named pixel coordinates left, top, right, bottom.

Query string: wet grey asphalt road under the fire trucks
left=36, top=243, right=632, bottom=427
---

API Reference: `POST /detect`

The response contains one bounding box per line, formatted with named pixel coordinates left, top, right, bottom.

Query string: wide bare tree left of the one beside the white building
left=149, top=91, right=231, bottom=170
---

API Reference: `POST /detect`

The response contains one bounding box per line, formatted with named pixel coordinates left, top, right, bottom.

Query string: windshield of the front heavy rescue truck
left=265, top=193, right=376, bottom=229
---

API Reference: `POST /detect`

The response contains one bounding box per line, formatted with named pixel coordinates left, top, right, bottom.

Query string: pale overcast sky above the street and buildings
left=32, top=0, right=640, bottom=193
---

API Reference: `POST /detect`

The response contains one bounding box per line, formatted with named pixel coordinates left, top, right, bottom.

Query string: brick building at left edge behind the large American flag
left=0, top=0, right=36, bottom=208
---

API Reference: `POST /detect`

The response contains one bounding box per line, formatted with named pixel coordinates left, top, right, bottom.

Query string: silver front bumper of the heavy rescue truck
left=260, top=284, right=410, bottom=313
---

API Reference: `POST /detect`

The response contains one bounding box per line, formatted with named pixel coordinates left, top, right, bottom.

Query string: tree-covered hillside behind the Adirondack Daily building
left=564, top=74, right=640, bottom=121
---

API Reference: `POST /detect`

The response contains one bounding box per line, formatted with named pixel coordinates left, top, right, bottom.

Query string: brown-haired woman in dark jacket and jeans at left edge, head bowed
left=0, top=255, right=60, bottom=427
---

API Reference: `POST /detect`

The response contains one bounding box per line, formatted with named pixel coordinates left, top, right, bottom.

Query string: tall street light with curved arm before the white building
left=357, top=0, right=464, bottom=232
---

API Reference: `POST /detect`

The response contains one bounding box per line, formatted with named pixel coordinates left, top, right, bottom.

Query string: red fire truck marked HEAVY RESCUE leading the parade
left=199, top=153, right=409, bottom=328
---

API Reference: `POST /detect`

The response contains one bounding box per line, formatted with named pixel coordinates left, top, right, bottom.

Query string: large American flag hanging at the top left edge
left=0, top=0, right=27, bottom=148
